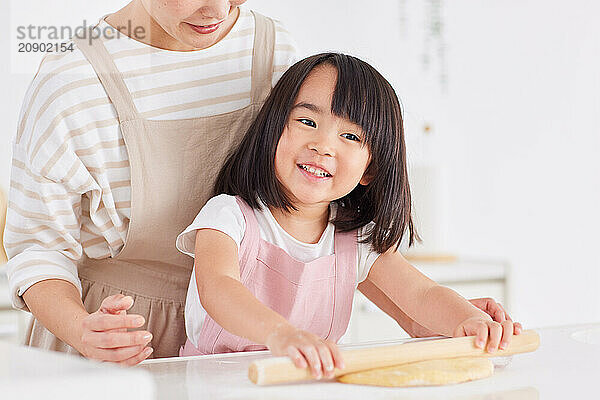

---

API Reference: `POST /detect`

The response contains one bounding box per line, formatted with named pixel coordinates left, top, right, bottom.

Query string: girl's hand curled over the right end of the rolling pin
left=453, top=315, right=514, bottom=353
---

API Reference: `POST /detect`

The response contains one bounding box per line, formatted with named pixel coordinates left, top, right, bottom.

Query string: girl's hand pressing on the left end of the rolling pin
left=266, top=326, right=344, bottom=379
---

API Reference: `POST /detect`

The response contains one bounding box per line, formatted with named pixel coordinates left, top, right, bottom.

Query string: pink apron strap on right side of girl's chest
left=327, top=229, right=358, bottom=342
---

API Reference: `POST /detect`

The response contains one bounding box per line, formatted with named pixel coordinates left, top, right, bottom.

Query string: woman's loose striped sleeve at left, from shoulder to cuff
left=4, top=52, right=105, bottom=310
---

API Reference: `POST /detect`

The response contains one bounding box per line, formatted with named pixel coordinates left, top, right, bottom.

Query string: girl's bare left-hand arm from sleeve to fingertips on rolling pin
left=194, top=229, right=343, bottom=379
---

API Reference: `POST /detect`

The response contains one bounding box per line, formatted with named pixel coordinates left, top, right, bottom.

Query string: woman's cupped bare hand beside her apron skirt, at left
left=78, top=294, right=153, bottom=365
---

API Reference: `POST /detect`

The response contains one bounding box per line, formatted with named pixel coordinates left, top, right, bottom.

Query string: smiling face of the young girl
left=275, top=64, right=370, bottom=206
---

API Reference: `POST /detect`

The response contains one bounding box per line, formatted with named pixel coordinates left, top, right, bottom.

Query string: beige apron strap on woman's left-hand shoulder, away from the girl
left=73, top=31, right=138, bottom=123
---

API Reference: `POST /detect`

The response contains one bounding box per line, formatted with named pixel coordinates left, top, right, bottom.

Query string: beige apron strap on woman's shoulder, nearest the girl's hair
left=250, top=11, right=275, bottom=104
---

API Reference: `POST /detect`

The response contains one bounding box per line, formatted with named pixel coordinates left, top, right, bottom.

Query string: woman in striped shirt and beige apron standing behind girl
left=5, top=0, right=520, bottom=365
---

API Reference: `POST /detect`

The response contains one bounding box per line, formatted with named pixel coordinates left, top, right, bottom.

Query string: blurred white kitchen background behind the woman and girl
left=0, top=0, right=600, bottom=341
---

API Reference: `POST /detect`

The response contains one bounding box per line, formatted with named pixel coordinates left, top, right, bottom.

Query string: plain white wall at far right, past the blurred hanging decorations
left=444, top=0, right=600, bottom=325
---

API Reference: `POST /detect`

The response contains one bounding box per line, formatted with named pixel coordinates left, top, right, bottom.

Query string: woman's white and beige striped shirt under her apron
left=4, top=8, right=295, bottom=309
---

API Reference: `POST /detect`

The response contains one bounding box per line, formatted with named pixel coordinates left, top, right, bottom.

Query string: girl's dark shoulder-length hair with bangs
left=214, top=53, right=419, bottom=253
